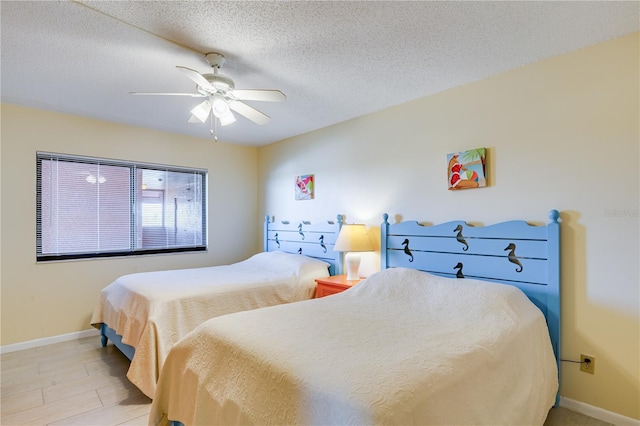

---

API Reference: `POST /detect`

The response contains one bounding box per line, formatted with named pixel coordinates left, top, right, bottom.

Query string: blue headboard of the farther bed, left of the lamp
left=264, top=215, right=343, bottom=275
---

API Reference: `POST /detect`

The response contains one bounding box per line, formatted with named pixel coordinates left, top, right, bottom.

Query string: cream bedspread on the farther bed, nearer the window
left=91, top=252, right=329, bottom=398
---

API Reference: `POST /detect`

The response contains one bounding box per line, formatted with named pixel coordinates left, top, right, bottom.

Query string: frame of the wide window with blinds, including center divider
left=36, top=151, right=208, bottom=263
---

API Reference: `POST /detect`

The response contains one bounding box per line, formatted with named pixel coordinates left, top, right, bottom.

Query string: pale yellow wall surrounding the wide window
left=0, top=104, right=261, bottom=345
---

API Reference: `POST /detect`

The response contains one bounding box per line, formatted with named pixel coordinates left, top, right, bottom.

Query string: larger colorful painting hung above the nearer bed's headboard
left=447, top=148, right=487, bottom=190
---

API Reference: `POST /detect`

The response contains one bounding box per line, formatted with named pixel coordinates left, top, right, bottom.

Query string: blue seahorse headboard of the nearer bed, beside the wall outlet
left=380, top=210, right=560, bottom=402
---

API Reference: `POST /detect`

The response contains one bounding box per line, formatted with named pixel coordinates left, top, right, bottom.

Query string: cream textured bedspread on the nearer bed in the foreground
left=149, top=269, right=558, bottom=426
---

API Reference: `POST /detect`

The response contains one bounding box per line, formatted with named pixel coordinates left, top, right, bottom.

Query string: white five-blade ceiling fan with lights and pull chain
left=129, top=52, right=287, bottom=135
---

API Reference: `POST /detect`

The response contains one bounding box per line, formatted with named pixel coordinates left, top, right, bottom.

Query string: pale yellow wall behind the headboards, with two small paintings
left=258, top=33, right=640, bottom=419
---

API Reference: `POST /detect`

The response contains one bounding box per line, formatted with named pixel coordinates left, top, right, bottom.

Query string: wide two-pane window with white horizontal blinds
left=36, top=152, right=207, bottom=261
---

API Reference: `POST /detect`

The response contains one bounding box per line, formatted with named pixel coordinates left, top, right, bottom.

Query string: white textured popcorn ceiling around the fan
left=0, top=0, right=640, bottom=146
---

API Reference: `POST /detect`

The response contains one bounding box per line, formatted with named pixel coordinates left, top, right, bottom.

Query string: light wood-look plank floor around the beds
left=0, top=337, right=607, bottom=426
